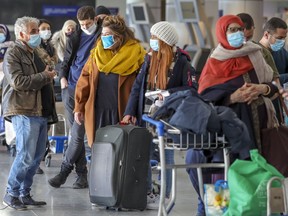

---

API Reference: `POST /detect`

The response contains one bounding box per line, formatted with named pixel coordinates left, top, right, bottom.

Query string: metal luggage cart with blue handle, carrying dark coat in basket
left=142, top=115, right=230, bottom=216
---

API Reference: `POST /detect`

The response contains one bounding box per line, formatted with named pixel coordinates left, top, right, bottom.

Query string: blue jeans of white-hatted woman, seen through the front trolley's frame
left=148, top=140, right=175, bottom=198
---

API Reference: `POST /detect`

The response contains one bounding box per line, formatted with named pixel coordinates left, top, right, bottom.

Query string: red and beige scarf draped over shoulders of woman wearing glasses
left=198, top=42, right=273, bottom=93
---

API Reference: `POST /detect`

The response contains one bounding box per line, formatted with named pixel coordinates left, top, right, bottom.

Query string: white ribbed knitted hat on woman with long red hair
left=150, top=21, right=178, bottom=46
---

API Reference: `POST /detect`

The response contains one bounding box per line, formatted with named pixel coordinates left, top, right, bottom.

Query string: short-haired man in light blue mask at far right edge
left=259, top=17, right=288, bottom=86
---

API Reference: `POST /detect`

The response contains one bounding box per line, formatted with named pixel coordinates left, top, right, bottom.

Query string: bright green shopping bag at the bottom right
left=224, top=150, right=284, bottom=216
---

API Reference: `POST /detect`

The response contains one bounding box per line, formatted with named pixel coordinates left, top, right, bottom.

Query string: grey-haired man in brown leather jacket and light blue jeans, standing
left=2, top=16, right=57, bottom=210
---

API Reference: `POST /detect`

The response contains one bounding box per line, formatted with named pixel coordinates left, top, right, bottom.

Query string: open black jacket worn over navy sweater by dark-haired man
left=59, top=25, right=102, bottom=80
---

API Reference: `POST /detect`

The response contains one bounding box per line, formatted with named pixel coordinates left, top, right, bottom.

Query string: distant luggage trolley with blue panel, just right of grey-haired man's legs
left=45, top=114, right=68, bottom=167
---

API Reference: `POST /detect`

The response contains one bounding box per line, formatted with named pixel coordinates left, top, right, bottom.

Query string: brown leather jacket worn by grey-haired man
left=2, top=40, right=52, bottom=120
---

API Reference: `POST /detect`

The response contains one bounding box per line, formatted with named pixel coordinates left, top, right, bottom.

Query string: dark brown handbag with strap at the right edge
left=261, top=97, right=288, bottom=177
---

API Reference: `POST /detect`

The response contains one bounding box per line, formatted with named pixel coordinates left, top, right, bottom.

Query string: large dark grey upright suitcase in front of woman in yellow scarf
left=89, top=125, right=152, bottom=210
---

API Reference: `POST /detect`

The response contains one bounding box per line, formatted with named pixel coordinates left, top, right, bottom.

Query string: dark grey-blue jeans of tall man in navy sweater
left=62, top=88, right=87, bottom=175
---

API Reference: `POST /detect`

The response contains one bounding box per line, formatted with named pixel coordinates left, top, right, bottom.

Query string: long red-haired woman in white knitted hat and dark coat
left=122, top=21, right=196, bottom=209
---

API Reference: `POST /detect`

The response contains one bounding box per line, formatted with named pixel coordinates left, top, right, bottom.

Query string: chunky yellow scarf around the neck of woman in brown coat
left=89, top=40, right=146, bottom=76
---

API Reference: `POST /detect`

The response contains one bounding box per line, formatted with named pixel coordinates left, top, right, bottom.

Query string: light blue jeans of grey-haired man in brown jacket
left=7, top=115, right=47, bottom=197
